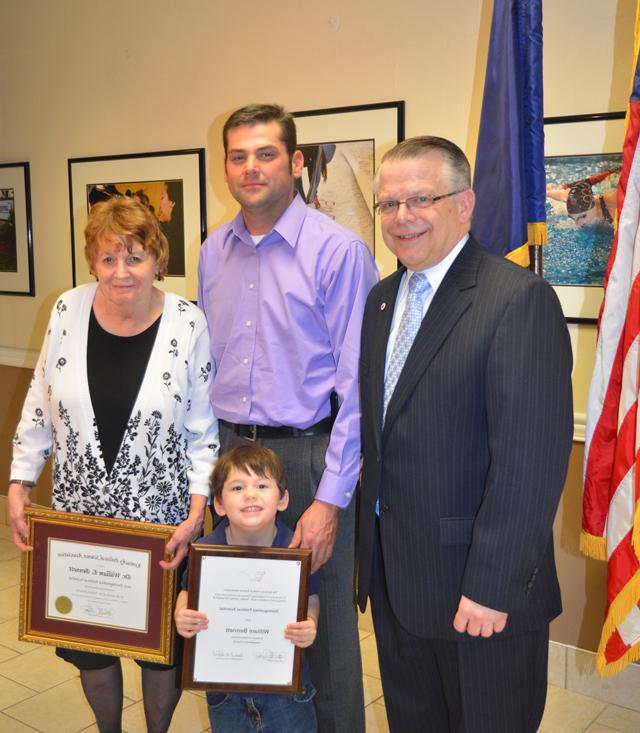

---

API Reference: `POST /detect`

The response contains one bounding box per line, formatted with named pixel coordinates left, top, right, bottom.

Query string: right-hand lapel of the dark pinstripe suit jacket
left=383, top=237, right=482, bottom=434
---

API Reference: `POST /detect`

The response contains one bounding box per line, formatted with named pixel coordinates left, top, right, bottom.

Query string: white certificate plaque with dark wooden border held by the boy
left=182, top=544, right=311, bottom=694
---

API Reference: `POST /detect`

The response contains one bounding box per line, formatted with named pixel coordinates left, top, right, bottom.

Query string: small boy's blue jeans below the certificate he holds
left=207, top=685, right=318, bottom=733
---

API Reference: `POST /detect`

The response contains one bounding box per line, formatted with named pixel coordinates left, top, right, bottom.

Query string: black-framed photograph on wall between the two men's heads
left=293, top=102, right=404, bottom=277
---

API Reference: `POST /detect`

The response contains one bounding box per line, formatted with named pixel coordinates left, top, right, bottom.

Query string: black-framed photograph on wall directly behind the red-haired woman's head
left=69, top=148, right=207, bottom=300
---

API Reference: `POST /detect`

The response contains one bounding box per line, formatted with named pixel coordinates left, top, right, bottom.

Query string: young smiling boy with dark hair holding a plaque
left=174, top=443, right=320, bottom=733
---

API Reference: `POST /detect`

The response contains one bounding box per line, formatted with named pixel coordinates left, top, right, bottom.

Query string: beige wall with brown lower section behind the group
left=0, top=0, right=635, bottom=648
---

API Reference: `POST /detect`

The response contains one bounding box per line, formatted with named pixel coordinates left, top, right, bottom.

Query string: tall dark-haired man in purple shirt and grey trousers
left=198, top=105, right=378, bottom=733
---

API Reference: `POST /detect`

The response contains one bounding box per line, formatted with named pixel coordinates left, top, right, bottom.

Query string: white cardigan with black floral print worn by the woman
left=11, top=284, right=218, bottom=525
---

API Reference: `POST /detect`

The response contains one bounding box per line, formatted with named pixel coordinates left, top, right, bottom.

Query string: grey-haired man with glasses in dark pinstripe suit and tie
left=358, top=137, right=573, bottom=733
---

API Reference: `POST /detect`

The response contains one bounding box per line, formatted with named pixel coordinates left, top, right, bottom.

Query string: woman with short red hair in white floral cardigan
left=9, top=198, right=218, bottom=733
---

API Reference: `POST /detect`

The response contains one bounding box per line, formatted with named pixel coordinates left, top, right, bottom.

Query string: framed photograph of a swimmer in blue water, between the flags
left=542, top=112, right=625, bottom=323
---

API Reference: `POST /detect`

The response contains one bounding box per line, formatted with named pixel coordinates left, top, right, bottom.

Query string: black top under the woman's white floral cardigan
left=87, top=309, right=161, bottom=473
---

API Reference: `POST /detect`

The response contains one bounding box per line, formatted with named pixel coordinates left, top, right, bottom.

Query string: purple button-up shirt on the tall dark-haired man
left=198, top=195, right=378, bottom=507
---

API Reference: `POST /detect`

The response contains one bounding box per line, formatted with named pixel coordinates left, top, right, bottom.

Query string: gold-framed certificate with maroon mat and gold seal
left=18, top=507, right=176, bottom=664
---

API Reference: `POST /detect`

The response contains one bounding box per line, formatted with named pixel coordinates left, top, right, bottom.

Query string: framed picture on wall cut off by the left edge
left=0, top=163, right=36, bottom=296
